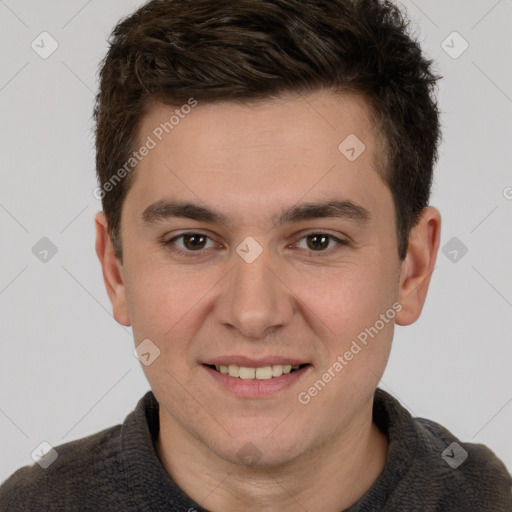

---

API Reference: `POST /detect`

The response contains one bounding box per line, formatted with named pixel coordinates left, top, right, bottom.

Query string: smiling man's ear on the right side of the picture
left=396, top=206, right=441, bottom=325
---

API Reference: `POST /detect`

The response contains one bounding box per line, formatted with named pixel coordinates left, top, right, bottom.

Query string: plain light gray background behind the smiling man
left=0, top=0, right=512, bottom=481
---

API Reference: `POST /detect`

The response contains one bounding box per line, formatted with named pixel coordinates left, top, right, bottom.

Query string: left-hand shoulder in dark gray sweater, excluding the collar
left=0, top=425, right=126, bottom=512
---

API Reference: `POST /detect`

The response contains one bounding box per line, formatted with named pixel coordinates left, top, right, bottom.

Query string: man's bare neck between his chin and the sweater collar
left=157, top=401, right=388, bottom=512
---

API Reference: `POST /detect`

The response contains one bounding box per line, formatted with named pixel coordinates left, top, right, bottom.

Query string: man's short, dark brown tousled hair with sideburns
left=94, top=0, right=440, bottom=259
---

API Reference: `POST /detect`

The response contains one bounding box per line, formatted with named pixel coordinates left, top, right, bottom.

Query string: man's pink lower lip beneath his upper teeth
left=203, top=365, right=310, bottom=398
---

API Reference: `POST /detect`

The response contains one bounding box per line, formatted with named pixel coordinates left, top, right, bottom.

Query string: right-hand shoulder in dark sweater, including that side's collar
left=370, top=388, right=512, bottom=512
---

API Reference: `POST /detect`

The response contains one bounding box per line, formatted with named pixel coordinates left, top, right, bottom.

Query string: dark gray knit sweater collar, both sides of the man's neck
left=120, top=388, right=417, bottom=512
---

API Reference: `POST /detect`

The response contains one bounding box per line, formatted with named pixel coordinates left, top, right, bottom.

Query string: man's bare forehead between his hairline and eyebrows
left=126, top=91, right=390, bottom=227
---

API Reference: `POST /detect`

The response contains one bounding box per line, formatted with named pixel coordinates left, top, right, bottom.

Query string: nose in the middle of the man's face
left=217, top=245, right=294, bottom=339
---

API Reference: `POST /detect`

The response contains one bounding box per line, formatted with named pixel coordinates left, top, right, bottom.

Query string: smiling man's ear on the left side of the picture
left=95, top=212, right=131, bottom=326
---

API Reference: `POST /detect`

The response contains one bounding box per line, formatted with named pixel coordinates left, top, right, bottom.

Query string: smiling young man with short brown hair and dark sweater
left=0, top=0, right=512, bottom=512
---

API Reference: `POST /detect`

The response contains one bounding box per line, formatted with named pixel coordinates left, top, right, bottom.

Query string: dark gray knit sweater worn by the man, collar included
left=0, top=389, right=512, bottom=512
